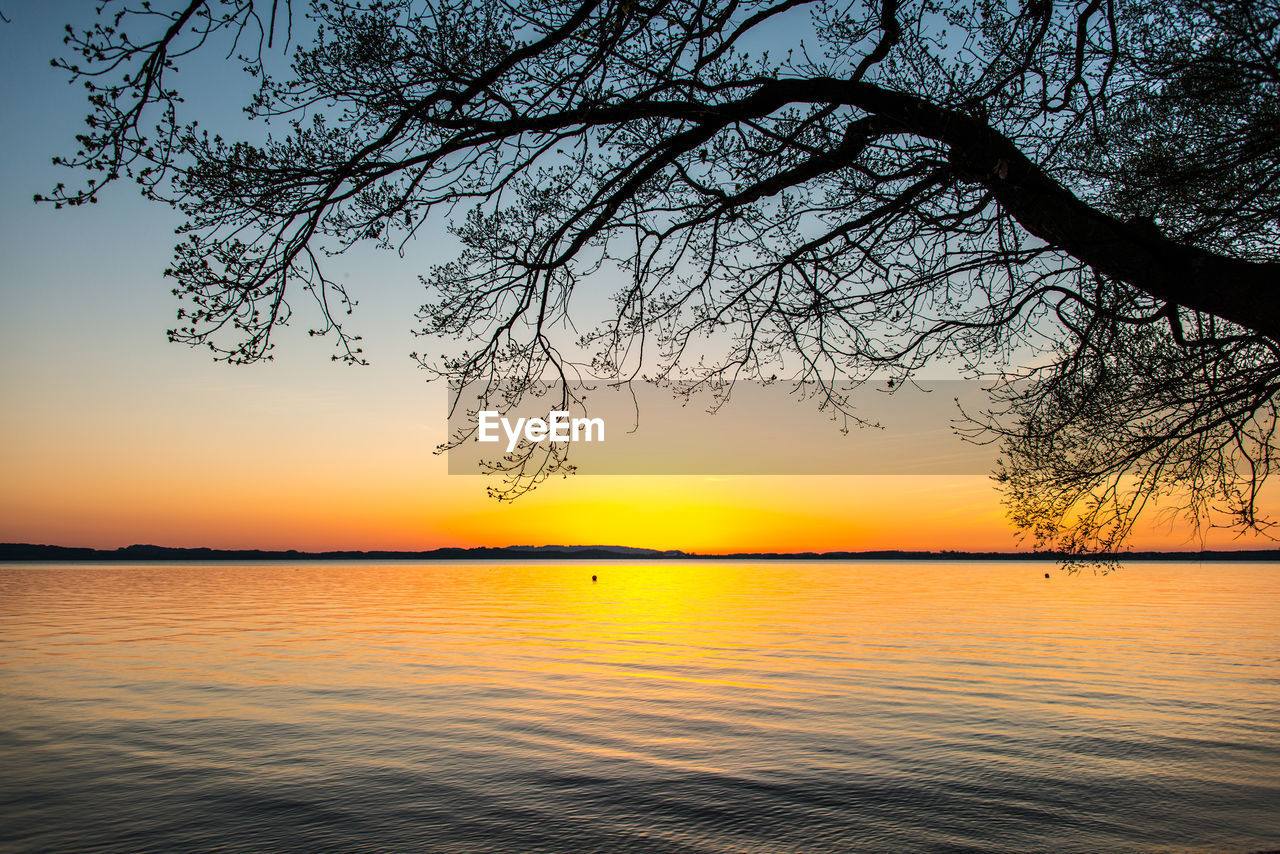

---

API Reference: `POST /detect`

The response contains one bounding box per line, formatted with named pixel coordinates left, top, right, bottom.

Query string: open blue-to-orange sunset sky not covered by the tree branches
left=0, top=1, right=1268, bottom=552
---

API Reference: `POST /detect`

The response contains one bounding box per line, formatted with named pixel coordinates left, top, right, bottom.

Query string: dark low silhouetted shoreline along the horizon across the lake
left=0, top=543, right=1280, bottom=563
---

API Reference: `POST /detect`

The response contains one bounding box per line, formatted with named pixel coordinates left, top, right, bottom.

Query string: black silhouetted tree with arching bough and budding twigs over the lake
left=49, top=0, right=1280, bottom=551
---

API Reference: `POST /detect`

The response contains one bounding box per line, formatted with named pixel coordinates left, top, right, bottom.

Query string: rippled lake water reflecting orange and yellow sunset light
left=0, top=563, right=1280, bottom=851
